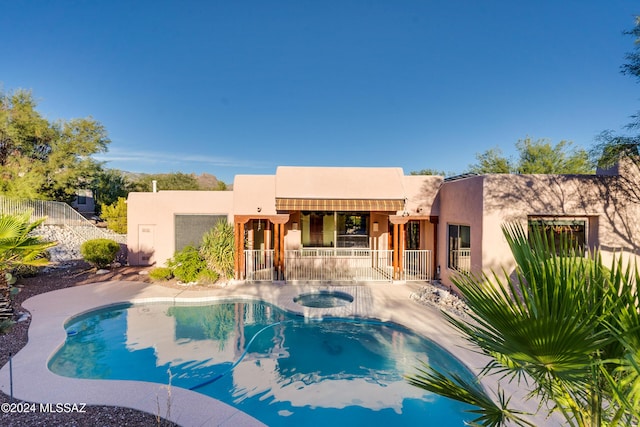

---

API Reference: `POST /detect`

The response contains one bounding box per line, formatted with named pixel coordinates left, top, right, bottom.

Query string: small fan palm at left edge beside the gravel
left=0, top=212, right=56, bottom=322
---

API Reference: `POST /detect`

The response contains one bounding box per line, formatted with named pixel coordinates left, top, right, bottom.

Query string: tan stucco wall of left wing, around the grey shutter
left=127, top=191, right=233, bottom=266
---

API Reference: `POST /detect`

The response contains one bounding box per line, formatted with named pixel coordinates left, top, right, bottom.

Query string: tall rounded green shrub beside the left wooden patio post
left=200, top=221, right=235, bottom=278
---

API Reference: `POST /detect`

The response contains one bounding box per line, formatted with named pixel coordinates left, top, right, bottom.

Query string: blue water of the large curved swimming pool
left=49, top=300, right=473, bottom=427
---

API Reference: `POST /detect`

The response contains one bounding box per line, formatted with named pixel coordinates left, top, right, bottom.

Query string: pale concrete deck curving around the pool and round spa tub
left=0, top=281, right=536, bottom=426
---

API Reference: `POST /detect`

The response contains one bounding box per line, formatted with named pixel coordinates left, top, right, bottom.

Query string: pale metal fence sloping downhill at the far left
left=0, top=196, right=127, bottom=243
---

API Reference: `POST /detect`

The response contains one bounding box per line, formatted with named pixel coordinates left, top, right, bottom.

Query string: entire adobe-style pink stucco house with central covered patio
left=127, top=166, right=640, bottom=284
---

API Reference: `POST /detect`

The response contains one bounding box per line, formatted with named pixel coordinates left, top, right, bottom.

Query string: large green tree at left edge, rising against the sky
left=0, top=90, right=110, bottom=203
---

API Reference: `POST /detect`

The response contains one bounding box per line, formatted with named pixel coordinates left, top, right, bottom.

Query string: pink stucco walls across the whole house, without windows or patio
left=127, top=167, right=640, bottom=284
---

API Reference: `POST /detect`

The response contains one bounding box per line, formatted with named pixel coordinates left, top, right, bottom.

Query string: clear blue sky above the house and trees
left=0, top=0, right=640, bottom=183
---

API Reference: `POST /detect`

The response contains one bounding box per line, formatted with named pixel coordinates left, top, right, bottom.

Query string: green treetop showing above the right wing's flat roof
left=469, top=137, right=594, bottom=174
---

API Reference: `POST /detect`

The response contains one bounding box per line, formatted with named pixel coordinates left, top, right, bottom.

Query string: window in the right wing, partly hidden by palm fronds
left=528, top=217, right=587, bottom=254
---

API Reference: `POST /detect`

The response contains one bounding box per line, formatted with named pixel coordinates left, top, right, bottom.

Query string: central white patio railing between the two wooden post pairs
left=284, top=248, right=393, bottom=282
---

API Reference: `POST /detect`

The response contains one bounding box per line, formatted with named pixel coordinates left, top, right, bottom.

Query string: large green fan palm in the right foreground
left=407, top=225, right=640, bottom=427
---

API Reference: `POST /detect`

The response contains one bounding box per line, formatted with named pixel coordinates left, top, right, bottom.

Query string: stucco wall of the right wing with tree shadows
left=438, top=174, right=640, bottom=284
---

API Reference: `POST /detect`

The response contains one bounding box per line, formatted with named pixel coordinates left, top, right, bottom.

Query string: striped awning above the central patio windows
left=276, top=198, right=404, bottom=212
